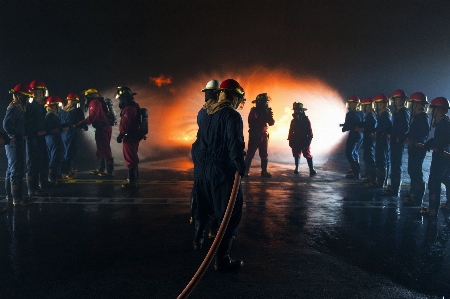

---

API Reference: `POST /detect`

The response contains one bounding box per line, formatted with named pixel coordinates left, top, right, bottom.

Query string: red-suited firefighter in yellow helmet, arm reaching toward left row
left=78, top=88, right=114, bottom=177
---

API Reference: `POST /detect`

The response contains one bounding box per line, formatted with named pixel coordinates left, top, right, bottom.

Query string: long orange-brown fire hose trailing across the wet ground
left=177, top=171, right=241, bottom=299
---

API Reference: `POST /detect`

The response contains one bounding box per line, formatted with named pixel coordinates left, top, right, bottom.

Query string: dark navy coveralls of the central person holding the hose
left=192, top=102, right=245, bottom=237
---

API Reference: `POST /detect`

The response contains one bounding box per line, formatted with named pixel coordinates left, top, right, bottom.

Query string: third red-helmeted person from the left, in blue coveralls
left=45, top=96, right=63, bottom=186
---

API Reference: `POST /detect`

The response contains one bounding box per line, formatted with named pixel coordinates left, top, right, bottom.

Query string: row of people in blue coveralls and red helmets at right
left=341, top=89, right=450, bottom=217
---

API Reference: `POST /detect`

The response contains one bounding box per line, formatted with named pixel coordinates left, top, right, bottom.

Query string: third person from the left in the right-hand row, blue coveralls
left=370, top=93, right=392, bottom=188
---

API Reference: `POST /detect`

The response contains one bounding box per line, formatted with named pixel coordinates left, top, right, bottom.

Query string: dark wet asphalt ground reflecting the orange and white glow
left=0, top=151, right=450, bottom=299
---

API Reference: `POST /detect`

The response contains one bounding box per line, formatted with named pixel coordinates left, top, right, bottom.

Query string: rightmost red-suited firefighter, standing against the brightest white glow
left=288, top=102, right=317, bottom=176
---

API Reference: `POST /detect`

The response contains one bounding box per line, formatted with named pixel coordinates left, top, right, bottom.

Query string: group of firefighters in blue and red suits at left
left=0, top=80, right=146, bottom=210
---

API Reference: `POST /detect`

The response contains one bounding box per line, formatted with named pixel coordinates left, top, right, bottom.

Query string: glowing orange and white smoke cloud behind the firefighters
left=96, top=67, right=346, bottom=163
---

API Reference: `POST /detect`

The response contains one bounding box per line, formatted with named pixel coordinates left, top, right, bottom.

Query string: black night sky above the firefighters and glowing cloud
left=0, top=0, right=450, bottom=106
